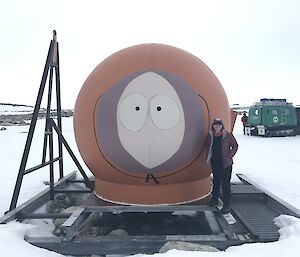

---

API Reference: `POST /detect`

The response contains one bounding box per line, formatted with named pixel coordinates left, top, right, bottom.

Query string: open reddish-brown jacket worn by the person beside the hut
left=206, top=129, right=239, bottom=169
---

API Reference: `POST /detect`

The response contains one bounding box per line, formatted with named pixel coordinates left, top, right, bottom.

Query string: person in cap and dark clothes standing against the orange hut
left=206, top=118, right=238, bottom=213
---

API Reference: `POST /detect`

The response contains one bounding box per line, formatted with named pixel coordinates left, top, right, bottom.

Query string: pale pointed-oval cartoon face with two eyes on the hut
left=117, top=72, right=185, bottom=169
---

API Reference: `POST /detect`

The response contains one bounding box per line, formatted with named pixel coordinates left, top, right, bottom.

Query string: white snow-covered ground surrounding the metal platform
left=0, top=113, right=300, bottom=257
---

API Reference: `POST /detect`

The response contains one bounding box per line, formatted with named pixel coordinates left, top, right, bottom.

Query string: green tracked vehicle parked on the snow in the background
left=246, top=98, right=299, bottom=137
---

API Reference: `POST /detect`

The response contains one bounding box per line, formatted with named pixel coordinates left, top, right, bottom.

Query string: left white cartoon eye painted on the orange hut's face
left=118, top=94, right=147, bottom=131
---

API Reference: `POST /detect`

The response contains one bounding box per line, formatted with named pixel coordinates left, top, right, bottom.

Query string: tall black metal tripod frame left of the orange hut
left=9, top=30, right=93, bottom=211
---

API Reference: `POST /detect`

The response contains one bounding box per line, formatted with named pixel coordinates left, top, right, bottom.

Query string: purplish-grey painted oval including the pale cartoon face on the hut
left=94, top=71, right=208, bottom=174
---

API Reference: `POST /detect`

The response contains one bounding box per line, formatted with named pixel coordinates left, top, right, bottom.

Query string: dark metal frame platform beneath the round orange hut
left=0, top=172, right=300, bottom=256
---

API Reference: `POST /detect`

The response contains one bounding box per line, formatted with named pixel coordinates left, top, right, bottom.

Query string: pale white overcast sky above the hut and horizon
left=0, top=0, right=300, bottom=108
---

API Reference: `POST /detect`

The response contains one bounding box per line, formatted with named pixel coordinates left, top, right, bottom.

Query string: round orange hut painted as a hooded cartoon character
left=74, top=44, right=231, bottom=205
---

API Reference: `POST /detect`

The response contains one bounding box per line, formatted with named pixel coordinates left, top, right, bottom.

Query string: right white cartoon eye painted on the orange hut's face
left=150, top=95, right=180, bottom=129
